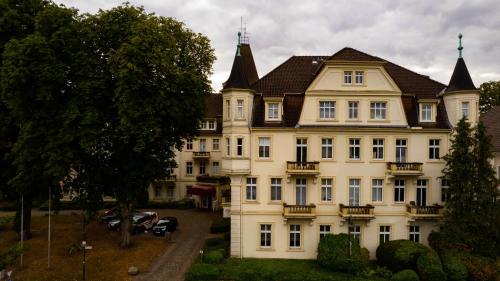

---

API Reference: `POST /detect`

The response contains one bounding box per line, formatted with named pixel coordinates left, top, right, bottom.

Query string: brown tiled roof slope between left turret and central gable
left=252, top=56, right=328, bottom=97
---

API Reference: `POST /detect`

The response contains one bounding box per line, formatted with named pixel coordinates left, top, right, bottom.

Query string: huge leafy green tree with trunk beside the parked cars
left=74, top=4, right=215, bottom=247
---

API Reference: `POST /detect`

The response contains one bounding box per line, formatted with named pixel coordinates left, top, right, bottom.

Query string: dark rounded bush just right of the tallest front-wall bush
left=376, top=240, right=429, bottom=272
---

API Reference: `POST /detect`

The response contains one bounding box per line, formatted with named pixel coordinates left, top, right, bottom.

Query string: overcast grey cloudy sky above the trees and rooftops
left=55, top=0, right=500, bottom=91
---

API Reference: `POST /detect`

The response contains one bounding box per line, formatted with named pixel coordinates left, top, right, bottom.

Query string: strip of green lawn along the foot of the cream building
left=186, top=258, right=385, bottom=281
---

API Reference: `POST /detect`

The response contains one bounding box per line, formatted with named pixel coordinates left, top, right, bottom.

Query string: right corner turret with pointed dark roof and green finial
left=443, top=34, right=479, bottom=126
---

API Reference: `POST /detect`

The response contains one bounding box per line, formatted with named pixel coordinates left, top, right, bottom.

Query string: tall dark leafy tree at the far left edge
left=0, top=1, right=79, bottom=238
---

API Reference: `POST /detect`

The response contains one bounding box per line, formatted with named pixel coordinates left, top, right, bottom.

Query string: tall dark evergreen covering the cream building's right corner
left=443, top=118, right=500, bottom=256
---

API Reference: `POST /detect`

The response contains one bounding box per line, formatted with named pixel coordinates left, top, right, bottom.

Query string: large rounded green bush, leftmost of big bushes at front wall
left=317, top=233, right=368, bottom=272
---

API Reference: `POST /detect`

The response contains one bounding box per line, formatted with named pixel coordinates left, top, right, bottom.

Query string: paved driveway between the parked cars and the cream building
left=134, top=210, right=216, bottom=281
